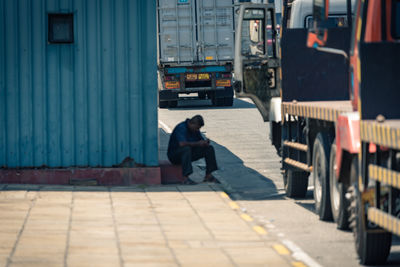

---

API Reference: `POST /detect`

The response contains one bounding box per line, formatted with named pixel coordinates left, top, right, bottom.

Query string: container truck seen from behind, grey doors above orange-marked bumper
left=157, top=0, right=235, bottom=108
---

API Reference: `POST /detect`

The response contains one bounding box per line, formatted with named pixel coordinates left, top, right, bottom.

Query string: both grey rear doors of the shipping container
left=158, top=0, right=235, bottom=64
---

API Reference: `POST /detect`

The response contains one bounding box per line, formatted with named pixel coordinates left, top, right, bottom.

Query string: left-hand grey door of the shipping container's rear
left=158, top=0, right=197, bottom=63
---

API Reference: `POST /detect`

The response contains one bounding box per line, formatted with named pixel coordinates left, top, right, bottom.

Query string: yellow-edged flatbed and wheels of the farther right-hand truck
left=282, top=100, right=354, bottom=224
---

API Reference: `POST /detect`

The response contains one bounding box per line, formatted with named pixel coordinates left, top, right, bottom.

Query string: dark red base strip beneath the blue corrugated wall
left=0, top=167, right=161, bottom=186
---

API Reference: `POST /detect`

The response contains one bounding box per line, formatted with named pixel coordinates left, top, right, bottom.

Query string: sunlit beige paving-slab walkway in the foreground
left=0, top=184, right=296, bottom=267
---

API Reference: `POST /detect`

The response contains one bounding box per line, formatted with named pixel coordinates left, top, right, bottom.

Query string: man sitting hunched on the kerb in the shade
left=167, top=115, right=218, bottom=184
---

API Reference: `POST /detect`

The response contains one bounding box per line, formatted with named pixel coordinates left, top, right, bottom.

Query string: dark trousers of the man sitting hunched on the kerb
left=168, top=146, right=218, bottom=176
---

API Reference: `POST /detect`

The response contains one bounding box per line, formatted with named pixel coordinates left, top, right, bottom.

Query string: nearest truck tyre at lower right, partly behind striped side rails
left=349, top=157, right=392, bottom=265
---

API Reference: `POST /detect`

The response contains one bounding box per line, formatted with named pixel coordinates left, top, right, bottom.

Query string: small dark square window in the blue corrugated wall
left=48, top=13, right=74, bottom=44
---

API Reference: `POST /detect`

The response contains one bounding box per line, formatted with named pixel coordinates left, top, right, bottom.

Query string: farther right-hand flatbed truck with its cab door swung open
left=234, top=0, right=353, bottom=229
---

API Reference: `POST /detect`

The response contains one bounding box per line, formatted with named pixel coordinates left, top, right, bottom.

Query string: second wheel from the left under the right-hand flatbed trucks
left=312, top=133, right=332, bottom=221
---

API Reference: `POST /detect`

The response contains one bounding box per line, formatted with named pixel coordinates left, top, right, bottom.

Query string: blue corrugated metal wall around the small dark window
left=0, top=0, right=158, bottom=168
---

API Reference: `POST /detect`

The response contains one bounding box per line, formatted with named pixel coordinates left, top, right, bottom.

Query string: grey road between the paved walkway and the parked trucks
left=159, top=99, right=400, bottom=267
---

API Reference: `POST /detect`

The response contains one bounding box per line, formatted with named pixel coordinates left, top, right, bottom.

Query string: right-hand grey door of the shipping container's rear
left=196, top=0, right=235, bottom=62
